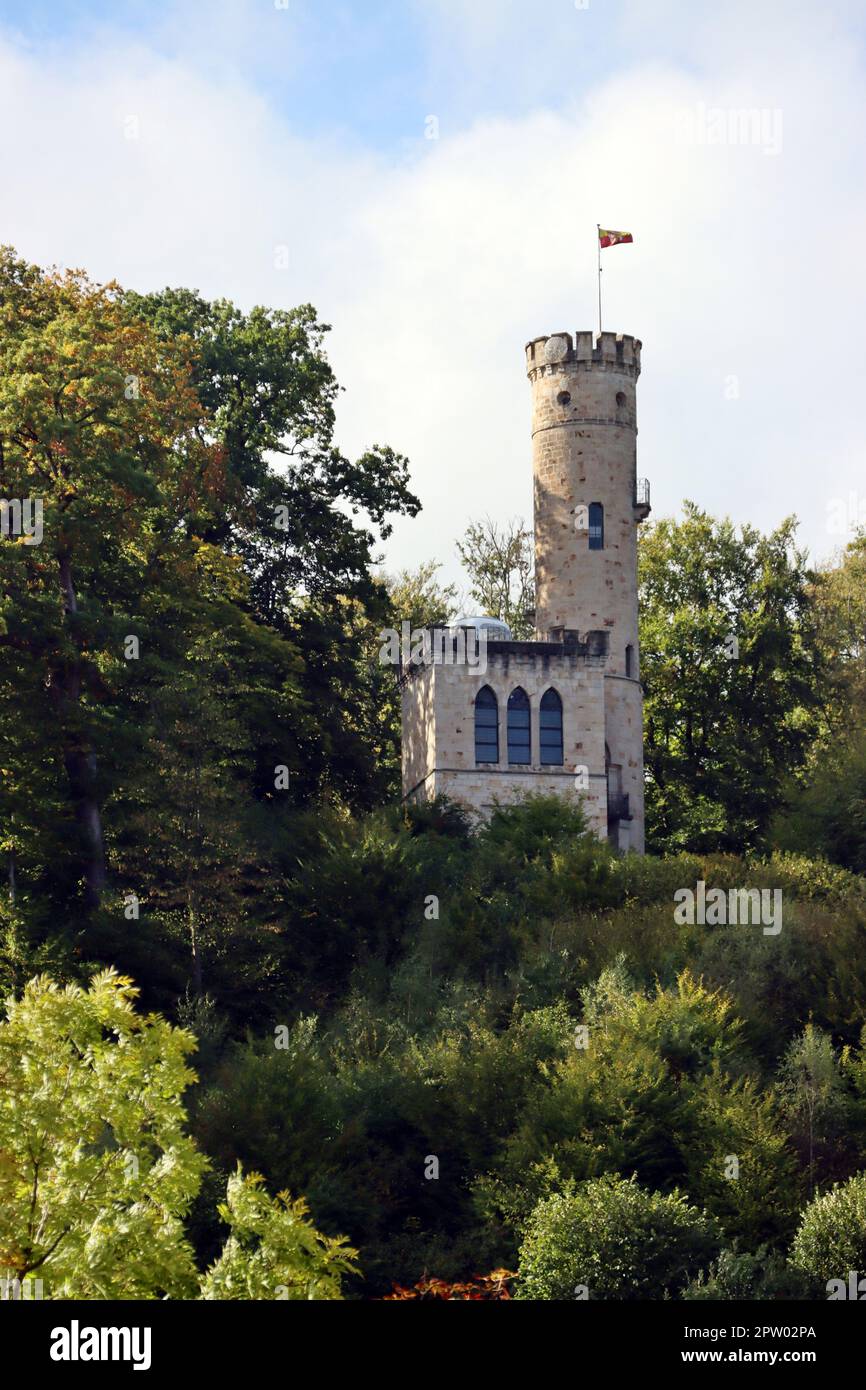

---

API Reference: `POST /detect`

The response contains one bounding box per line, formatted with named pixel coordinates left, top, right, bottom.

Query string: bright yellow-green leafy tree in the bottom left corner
left=0, top=970, right=207, bottom=1298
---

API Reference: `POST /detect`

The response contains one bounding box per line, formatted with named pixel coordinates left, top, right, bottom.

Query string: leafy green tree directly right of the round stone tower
left=639, top=502, right=824, bottom=852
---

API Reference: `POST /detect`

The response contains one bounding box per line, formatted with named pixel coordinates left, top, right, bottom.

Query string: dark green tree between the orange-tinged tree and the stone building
left=126, top=289, right=420, bottom=806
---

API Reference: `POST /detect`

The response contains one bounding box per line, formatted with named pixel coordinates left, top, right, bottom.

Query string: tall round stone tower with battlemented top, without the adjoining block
left=527, top=332, right=649, bottom=852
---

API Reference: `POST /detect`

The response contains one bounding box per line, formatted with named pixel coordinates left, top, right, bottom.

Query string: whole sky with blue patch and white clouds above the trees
left=0, top=0, right=866, bottom=580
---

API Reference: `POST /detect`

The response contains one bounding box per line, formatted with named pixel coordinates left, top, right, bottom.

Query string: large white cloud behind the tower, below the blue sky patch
left=0, top=0, right=866, bottom=586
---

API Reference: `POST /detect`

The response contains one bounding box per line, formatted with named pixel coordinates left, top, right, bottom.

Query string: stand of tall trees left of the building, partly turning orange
left=0, top=249, right=418, bottom=1016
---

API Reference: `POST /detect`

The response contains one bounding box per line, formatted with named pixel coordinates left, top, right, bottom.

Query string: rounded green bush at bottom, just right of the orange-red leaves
left=517, top=1176, right=719, bottom=1300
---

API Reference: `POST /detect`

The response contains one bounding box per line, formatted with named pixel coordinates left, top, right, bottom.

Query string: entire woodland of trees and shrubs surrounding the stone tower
left=0, top=249, right=866, bottom=1298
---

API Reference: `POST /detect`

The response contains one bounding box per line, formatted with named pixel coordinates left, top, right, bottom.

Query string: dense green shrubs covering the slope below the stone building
left=10, top=799, right=866, bottom=1297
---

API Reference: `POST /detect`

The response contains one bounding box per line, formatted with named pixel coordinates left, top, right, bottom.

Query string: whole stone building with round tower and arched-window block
left=400, top=332, right=649, bottom=852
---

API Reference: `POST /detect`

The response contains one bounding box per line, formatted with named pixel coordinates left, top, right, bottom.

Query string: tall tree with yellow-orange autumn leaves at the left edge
left=0, top=249, right=221, bottom=908
